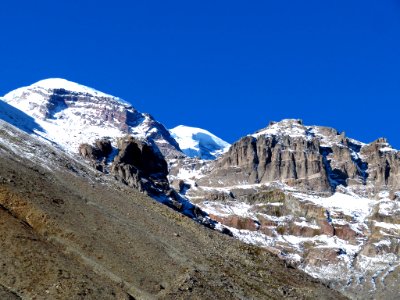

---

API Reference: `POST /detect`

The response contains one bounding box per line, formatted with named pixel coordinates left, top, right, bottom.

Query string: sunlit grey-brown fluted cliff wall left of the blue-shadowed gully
left=208, top=136, right=329, bottom=192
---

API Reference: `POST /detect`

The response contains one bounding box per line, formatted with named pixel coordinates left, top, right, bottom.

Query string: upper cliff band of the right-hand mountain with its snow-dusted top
left=199, top=120, right=400, bottom=195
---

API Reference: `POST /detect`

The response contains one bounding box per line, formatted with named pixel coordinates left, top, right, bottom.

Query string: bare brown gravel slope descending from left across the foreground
left=0, top=116, right=341, bottom=299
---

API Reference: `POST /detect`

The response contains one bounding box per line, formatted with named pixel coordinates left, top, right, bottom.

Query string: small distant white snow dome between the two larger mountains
left=170, top=125, right=230, bottom=159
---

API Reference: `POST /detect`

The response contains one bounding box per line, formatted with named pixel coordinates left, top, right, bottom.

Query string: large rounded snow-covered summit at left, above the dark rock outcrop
left=3, top=78, right=180, bottom=156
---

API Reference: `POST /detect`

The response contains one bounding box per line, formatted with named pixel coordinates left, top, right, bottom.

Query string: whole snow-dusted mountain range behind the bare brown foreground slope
left=0, top=79, right=400, bottom=299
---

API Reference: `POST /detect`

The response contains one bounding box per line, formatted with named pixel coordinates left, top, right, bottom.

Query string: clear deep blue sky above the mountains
left=0, top=0, right=400, bottom=148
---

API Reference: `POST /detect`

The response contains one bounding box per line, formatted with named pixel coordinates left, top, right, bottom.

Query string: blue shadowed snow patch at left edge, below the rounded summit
left=0, top=99, right=44, bottom=133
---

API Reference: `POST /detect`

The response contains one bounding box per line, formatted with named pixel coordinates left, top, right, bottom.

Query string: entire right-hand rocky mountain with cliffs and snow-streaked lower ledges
left=174, top=120, right=400, bottom=299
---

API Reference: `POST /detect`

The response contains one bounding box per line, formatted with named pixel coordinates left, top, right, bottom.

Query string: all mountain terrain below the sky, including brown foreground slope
left=0, top=79, right=400, bottom=299
